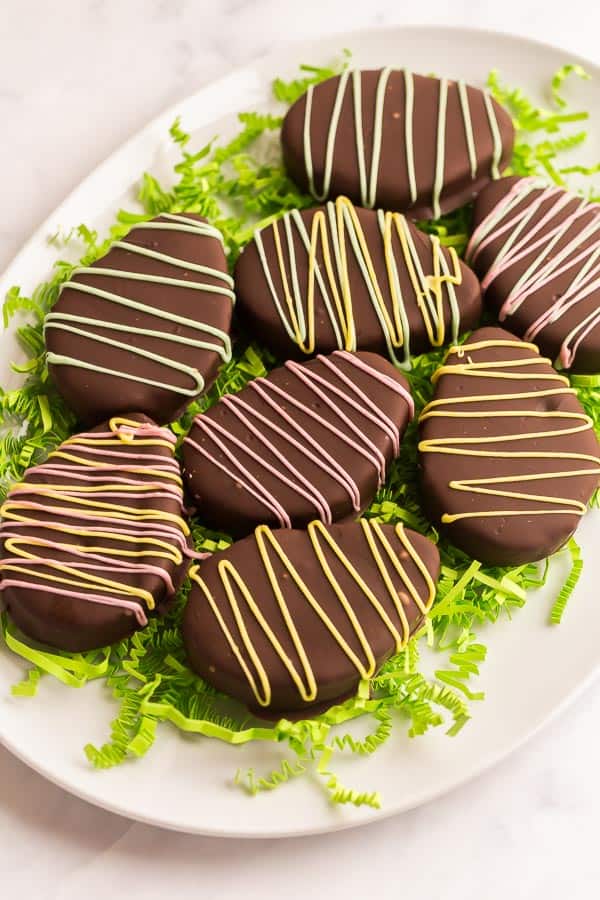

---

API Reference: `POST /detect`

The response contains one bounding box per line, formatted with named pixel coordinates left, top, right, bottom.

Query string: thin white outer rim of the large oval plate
left=0, top=23, right=600, bottom=840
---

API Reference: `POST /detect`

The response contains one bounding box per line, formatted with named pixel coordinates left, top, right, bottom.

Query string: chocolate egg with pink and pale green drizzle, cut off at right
left=467, top=178, right=600, bottom=373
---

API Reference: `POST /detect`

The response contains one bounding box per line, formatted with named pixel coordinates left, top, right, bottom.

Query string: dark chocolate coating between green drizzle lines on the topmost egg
left=281, top=69, right=514, bottom=219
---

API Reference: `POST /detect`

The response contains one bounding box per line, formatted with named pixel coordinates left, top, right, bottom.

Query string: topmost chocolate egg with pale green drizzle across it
left=281, top=66, right=514, bottom=219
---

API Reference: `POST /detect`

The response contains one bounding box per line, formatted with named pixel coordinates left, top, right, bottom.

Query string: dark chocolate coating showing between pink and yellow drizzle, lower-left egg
left=0, top=414, right=188, bottom=652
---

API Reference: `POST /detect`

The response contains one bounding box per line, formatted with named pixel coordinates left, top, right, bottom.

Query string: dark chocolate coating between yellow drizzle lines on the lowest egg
left=183, top=523, right=439, bottom=716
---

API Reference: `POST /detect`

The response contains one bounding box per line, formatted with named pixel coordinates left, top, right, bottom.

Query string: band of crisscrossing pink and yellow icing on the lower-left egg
left=0, top=417, right=189, bottom=626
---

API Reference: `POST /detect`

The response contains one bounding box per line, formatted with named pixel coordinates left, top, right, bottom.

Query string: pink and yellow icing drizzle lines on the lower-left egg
left=0, top=423, right=188, bottom=626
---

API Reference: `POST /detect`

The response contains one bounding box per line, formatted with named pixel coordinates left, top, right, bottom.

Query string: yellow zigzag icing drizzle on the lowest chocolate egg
left=190, top=519, right=435, bottom=707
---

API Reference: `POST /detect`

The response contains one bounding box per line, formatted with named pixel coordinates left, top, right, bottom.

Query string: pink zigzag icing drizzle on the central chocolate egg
left=185, top=351, right=414, bottom=528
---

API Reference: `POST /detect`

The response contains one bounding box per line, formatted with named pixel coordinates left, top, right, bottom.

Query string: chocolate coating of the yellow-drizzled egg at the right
left=419, top=328, right=600, bottom=565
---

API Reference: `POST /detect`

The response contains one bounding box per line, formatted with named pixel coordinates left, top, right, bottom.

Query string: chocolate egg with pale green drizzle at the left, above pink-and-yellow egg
left=45, top=213, right=234, bottom=424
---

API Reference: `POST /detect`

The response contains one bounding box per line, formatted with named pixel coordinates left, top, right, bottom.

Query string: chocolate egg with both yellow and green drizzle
left=235, top=197, right=481, bottom=368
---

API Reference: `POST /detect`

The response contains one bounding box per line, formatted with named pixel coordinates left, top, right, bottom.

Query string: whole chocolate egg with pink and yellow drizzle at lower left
left=0, top=414, right=189, bottom=652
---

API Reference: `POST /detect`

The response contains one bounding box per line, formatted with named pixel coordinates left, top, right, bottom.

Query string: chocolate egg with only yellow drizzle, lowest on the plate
left=183, top=519, right=439, bottom=718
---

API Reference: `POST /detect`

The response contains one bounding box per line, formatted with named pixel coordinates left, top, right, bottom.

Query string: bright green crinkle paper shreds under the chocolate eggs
left=0, top=54, right=600, bottom=808
